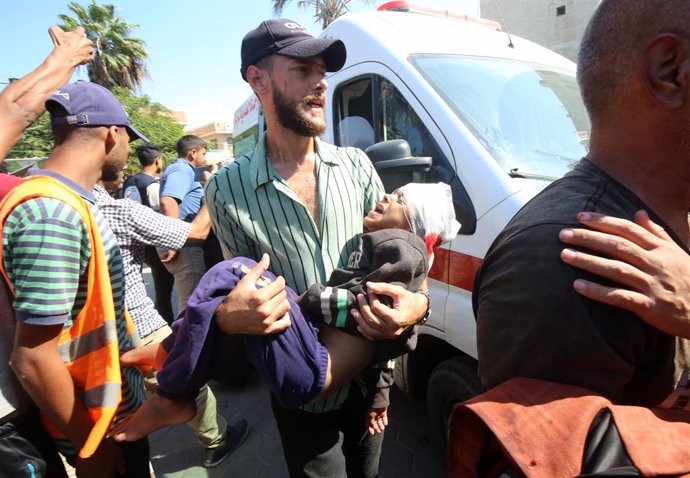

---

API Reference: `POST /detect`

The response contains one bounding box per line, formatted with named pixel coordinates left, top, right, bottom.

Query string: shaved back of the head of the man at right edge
left=577, top=0, right=690, bottom=122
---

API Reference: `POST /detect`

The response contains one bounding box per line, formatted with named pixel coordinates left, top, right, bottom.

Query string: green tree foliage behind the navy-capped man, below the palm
left=8, top=87, right=184, bottom=172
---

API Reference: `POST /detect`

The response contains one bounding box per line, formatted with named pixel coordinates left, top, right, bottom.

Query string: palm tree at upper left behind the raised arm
left=58, top=0, right=148, bottom=91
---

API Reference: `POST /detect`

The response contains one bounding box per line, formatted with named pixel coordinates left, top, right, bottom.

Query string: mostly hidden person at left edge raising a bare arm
left=0, top=25, right=93, bottom=478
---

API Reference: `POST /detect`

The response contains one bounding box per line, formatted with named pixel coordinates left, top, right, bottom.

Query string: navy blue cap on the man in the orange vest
left=45, top=81, right=151, bottom=143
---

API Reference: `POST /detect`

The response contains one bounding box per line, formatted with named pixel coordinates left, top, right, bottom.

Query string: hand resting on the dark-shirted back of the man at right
left=559, top=211, right=690, bottom=338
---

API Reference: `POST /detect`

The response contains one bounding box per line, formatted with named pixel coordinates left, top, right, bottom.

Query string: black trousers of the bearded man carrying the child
left=271, top=383, right=383, bottom=478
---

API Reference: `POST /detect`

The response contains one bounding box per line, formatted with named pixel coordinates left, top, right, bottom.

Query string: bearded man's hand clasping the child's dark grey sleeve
left=352, top=282, right=428, bottom=340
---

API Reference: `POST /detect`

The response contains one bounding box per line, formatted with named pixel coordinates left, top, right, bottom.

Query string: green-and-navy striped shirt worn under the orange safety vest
left=2, top=170, right=146, bottom=454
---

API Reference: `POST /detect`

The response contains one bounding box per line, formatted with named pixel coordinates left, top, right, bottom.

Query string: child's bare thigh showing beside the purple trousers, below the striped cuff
left=316, top=326, right=375, bottom=400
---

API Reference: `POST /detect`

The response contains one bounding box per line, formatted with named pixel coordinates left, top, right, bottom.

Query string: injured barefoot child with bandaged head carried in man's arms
left=111, top=183, right=460, bottom=441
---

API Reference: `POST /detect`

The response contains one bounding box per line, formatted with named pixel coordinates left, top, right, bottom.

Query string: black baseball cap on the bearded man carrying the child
left=240, top=18, right=347, bottom=81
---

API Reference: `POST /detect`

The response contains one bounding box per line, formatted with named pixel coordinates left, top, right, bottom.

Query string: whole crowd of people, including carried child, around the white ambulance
left=0, top=0, right=690, bottom=477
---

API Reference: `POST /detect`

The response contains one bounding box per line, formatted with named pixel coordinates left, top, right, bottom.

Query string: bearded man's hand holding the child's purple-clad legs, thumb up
left=216, top=254, right=290, bottom=335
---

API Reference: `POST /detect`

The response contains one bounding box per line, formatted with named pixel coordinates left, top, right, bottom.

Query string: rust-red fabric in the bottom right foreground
left=448, top=378, right=690, bottom=478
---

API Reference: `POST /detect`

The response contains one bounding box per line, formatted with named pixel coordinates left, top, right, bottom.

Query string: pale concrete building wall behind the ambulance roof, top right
left=480, top=0, right=600, bottom=61
